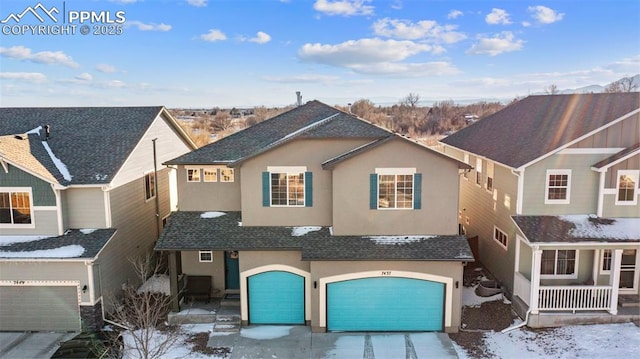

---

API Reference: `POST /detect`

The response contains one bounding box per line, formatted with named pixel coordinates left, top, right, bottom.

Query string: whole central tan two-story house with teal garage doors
left=156, top=101, right=473, bottom=332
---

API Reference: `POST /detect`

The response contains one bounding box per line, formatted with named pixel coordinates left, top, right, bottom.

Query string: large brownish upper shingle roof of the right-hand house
left=441, top=92, right=640, bottom=168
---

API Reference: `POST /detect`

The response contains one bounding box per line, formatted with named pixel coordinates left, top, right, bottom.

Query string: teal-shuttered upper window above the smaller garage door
left=262, top=166, right=313, bottom=207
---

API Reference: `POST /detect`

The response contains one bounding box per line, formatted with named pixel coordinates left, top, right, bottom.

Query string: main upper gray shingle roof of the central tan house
left=166, top=100, right=392, bottom=165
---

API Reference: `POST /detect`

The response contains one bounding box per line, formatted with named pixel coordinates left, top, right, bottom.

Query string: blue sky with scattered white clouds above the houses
left=0, top=0, right=640, bottom=108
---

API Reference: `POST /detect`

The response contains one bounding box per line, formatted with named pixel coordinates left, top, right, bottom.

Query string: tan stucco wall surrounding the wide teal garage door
left=311, top=261, right=464, bottom=332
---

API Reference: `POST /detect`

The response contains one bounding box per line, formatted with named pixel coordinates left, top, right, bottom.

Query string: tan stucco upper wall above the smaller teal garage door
left=241, top=139, right=368, bottom=226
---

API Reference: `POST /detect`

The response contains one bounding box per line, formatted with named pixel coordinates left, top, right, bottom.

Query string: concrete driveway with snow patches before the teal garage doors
left=208, top=326, right=458, bottom=359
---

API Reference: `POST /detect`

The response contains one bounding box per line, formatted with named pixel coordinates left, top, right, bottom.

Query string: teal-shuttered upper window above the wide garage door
left=370, top=168, right=422, bottom=209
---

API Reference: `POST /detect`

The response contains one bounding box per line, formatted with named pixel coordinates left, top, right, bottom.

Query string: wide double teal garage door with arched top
left=327, top=277, right=444, bottom=331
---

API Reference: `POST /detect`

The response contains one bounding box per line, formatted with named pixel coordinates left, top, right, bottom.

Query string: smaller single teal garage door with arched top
left=248, top=271, right=304, bottom=324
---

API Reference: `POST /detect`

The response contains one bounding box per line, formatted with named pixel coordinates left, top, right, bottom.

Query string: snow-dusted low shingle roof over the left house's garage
left=0, top=229, right=116, bottom=259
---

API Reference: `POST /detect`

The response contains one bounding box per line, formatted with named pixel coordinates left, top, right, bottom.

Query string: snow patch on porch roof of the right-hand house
left=558, top=214, right=640, bottom=239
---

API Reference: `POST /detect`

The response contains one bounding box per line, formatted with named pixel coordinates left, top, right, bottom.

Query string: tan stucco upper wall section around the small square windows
left=177, top=166, right=242, bottom=211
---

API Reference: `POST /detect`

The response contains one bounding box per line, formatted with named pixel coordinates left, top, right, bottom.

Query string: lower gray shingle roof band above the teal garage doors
left=155, top=212, right=473, bottom=261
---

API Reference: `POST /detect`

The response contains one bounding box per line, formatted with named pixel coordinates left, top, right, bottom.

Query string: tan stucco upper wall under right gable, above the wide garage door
left=333, top=139, right=459, bottom=235
